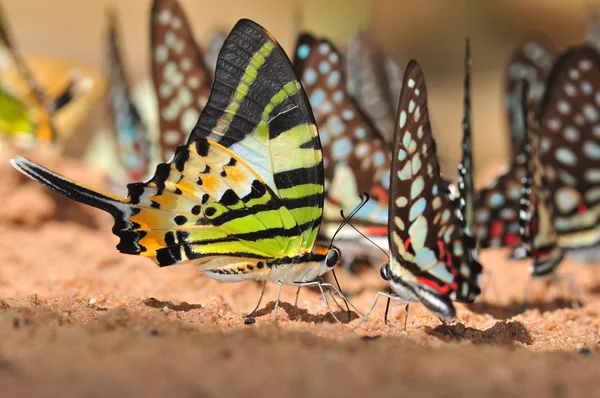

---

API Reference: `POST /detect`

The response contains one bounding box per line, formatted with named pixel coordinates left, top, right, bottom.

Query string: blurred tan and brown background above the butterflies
left=2, top=0, right=595, bottom=180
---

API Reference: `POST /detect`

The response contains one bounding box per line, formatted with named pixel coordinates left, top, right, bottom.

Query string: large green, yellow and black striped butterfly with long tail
left=12, top=19, right=341, bottom=320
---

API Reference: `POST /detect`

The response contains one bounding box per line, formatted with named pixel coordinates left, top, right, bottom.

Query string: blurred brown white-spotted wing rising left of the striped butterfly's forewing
left=150, top=0, right=212, bottom=161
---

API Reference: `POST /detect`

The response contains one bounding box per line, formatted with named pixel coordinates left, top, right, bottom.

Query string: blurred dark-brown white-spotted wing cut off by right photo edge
left=538, top=46, right=600, bottom=248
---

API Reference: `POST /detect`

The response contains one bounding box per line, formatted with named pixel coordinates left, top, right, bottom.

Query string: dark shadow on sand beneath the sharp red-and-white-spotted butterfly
left=425, top=321, right=533, bottom=345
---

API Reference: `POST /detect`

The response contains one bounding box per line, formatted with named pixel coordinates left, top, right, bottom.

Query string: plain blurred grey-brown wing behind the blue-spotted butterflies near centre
left=343, top=32, right=402, bottom=142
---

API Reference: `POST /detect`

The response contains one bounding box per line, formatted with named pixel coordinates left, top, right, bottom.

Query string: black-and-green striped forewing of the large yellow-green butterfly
left=189, top=20, right=324, bottom=249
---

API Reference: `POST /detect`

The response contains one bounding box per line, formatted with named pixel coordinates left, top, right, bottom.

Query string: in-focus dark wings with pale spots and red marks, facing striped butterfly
left=388, top=61, right=482, bottom=318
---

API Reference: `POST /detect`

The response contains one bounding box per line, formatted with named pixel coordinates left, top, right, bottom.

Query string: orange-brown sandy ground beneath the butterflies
left=0, top=150, right=600, bottom=397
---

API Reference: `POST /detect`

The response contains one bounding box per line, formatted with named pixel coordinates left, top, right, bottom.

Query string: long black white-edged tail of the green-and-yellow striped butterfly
left=10, top=156, right=131, bottom=220
